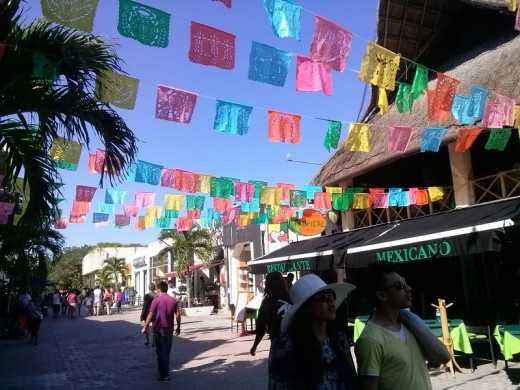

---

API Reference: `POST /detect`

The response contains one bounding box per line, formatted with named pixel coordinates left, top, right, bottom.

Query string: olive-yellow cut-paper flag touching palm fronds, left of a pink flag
left=94, top=71, right=139, bottom=110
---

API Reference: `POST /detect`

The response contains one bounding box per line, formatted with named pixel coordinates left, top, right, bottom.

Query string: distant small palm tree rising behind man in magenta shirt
left=158, top=229, right=212, bottom=307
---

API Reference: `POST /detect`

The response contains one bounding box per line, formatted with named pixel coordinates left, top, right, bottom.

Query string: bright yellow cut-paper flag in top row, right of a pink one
left=359, top=42, right=401, bottom=91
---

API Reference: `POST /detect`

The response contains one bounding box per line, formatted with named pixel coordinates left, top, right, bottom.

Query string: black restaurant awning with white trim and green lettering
left=249, top=197, right=520, bottom=274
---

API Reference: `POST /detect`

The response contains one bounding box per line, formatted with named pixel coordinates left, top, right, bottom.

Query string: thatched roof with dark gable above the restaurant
left=311, top=0, right=520, bottom=185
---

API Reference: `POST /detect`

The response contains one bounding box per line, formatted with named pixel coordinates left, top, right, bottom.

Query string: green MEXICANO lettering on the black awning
left=376, top=241, right=451, bottom=263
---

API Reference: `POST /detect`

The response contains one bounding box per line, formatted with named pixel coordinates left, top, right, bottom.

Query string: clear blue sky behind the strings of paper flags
left=21, top=0, right=378, bottom=246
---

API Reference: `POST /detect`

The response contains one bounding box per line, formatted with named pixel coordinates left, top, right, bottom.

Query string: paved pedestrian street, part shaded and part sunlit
left=0, top=308, right=520, bottom=390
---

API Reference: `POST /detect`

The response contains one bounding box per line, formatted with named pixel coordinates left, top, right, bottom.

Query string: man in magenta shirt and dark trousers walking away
left=141, top=281, right=181, bottom=382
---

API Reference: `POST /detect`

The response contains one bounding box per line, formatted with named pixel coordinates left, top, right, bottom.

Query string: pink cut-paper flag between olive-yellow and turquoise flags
left=155, top=85, right=198, bottom=123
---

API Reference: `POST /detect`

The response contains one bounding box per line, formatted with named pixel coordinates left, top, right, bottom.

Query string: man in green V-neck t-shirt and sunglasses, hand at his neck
left=355, top=262, right=450, bottom=390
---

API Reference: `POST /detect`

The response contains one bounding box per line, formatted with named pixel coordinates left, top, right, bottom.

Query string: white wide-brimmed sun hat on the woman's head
left=281, top=274, right=356, bottom=333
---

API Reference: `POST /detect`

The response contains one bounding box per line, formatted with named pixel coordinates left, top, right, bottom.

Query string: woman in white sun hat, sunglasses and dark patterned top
left=268, top=275, right=356, bottom=390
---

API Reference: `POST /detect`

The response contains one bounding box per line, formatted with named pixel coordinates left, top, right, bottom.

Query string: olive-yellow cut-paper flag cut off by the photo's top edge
left=41, top=0, right=99, bottom=32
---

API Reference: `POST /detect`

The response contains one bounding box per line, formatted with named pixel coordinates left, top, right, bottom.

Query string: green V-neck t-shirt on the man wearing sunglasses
left=355, top=321, right=432, bottom=390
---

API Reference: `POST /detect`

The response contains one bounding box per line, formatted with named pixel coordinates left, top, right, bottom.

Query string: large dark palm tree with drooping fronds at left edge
left=0, top=0, right=137, bottom=225
